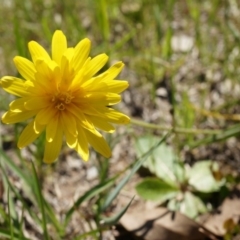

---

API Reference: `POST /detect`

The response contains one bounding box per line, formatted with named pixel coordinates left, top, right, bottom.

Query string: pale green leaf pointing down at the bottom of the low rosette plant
left=180, top=192, right=207, bottom=218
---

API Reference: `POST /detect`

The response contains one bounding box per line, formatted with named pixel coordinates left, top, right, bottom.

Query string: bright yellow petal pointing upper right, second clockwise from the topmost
left=84, top=53, right=108, bottom=80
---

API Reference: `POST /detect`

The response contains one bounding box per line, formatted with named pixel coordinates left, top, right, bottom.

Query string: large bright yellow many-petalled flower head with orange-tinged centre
left=0, top=30, right=129, bottom=163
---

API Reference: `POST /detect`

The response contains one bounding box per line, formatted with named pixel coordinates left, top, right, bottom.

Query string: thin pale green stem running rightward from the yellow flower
left=131, top=119, right=222, bottom=135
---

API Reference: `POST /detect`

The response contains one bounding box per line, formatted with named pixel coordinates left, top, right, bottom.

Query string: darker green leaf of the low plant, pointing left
left=136, top=178, right=179, bottom=203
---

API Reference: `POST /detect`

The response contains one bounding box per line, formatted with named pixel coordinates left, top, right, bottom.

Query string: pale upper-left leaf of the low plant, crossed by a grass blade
left=135, top=135, right=177, bottom=186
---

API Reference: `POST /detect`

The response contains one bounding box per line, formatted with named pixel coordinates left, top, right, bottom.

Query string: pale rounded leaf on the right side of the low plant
left=188, top=160, right=225, bottom=193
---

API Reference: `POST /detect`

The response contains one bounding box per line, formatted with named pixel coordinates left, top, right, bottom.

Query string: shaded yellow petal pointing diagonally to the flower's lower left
left=18, top=121, right=44, bottom=148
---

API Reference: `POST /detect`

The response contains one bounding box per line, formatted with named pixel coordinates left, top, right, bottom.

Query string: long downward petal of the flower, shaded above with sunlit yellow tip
left=75, top=124, right=89, bottom=161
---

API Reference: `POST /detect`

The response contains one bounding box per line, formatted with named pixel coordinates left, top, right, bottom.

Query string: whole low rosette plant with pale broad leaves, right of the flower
left=136, top=136, right=225, bottom=218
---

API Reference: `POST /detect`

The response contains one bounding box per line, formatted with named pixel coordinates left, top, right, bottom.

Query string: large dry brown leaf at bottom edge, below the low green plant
left=120, top=208, right=216, bottom=240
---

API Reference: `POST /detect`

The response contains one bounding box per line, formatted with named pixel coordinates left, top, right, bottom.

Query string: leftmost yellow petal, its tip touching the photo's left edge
left=0, top=76, right=30, bottom=97
